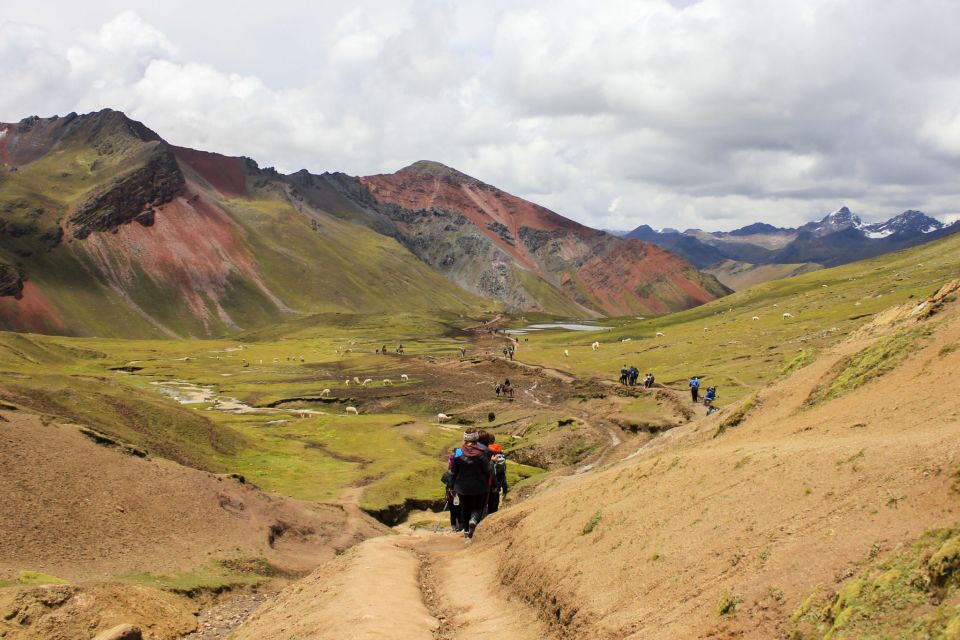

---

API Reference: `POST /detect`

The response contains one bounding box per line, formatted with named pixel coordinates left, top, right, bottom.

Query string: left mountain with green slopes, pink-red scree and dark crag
left=0, top=110, right=485, bottom=337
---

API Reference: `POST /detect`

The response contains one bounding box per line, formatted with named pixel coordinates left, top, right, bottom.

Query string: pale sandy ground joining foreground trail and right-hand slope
left=231, top=282, right=960, bottom=640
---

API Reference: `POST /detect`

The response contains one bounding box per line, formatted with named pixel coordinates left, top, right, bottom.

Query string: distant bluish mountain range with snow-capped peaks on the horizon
left=624, top=207, right=960, bottom=269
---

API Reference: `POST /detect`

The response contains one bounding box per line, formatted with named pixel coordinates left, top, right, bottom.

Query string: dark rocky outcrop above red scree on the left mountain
left=69, top=143, right=185, bottom=240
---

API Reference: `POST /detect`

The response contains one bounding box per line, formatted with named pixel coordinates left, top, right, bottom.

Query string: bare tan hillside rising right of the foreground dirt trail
left=477, top=282, right=960, bottom=638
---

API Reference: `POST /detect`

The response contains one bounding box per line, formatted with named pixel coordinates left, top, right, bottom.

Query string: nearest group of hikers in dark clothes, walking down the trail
left=441, top=430, right=509, bottom=538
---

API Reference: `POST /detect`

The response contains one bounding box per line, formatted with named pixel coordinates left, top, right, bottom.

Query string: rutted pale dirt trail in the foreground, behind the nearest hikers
left=235, top=533, right=552, bottom=640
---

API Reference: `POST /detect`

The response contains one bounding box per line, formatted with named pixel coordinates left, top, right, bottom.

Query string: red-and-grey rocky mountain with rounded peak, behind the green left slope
left=316, top=161, right=728, bottom=316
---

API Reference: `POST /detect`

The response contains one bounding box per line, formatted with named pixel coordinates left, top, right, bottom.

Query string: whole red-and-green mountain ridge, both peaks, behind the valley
left=0, top=109, right=726, bottom=337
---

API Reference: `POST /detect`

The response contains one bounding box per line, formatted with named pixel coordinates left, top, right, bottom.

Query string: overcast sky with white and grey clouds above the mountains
left=0, top=0, right=960, bottom=230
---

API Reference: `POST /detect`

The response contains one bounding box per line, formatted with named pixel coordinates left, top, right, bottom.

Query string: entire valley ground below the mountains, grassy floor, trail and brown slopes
left=0, top=224, right=960, bottom=638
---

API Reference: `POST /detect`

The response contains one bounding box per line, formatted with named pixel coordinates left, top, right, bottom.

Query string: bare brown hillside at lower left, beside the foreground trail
left=0, top=407, right=383, bottom=640
